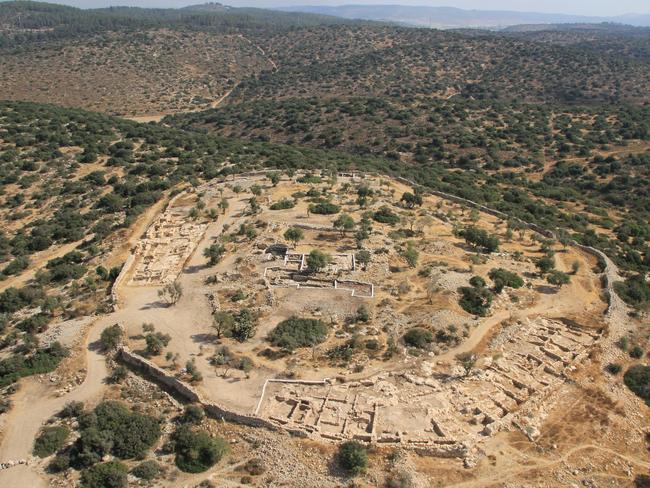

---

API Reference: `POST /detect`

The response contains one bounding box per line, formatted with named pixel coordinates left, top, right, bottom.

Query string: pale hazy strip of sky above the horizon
left=40, top=0, right=650, bottom=15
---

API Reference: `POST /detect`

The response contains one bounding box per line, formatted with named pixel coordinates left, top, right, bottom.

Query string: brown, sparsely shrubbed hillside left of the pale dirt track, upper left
left=0, top=30, right=271, bottom=116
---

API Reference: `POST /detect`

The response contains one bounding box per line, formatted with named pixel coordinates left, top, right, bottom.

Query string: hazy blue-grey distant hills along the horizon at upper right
left=279, top=5, right=650, bottom=29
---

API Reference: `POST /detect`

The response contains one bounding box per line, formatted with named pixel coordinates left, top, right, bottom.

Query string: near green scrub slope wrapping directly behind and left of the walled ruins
left=0, top=102, right=650, bottom=302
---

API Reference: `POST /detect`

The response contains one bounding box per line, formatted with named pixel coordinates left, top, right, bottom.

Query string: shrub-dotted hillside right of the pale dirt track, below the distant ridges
left=237, top=26, right=650, bottom=103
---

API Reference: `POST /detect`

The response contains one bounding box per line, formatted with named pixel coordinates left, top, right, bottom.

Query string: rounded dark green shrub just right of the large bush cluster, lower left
left=174, top=427, right=229, bottom=473
